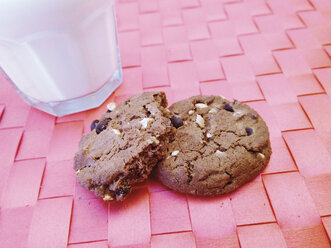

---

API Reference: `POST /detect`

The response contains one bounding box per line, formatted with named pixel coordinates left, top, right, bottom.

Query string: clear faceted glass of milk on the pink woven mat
left=0, top=0, right=122, bottom=116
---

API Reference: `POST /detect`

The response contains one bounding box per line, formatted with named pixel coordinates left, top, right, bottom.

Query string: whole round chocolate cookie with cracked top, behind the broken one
left=155, top=96, right=271, bottom=196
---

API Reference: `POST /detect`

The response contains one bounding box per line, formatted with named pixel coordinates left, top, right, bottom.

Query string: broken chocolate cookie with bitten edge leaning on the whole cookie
left=74, top=92, right=173, bottom=201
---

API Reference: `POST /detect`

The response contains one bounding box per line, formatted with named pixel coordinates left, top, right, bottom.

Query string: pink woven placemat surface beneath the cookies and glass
left=0, top=0, right=331, bottom=248
